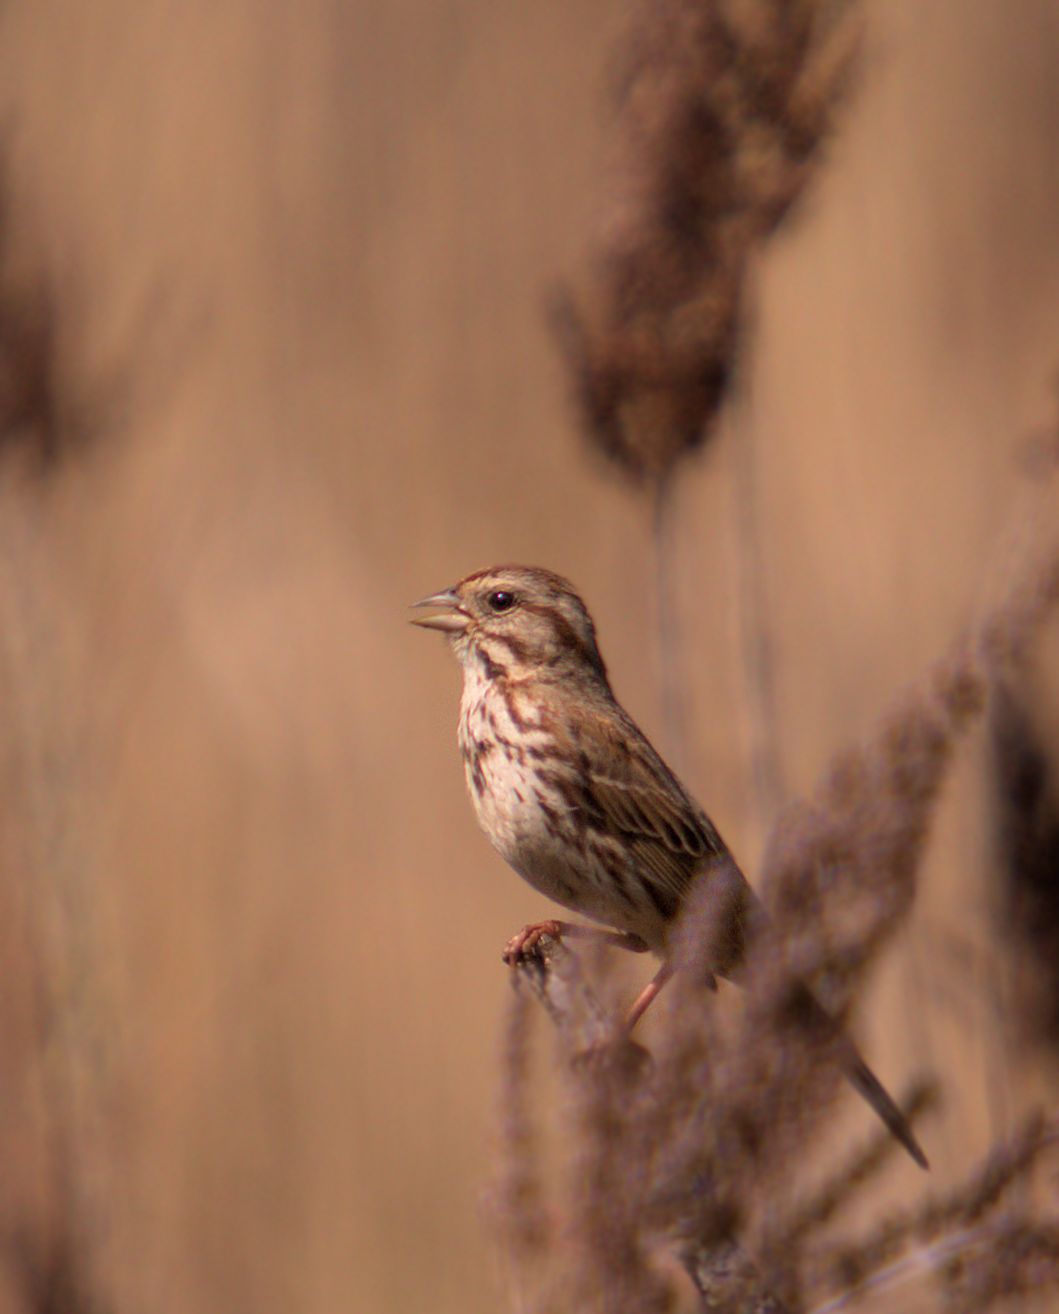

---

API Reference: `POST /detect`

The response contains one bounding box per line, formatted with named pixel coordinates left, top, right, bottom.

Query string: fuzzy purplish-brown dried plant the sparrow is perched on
left=488, top=488, right=1059, bottom=1314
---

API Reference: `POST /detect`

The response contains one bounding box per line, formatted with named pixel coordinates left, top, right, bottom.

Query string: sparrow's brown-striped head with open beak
left=413, top=566, right=606, bottom=679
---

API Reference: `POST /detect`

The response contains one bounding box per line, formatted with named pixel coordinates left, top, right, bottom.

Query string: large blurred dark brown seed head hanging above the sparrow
left=557, top=0, right=857, bottom=485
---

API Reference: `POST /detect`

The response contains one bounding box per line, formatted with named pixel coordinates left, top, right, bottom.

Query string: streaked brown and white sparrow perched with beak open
left=414, top=566, right=926, bottom=1167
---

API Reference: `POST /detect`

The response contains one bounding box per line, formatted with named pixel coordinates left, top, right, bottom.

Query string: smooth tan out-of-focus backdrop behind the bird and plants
left=0, top=0, right=1059, bottom=1314
